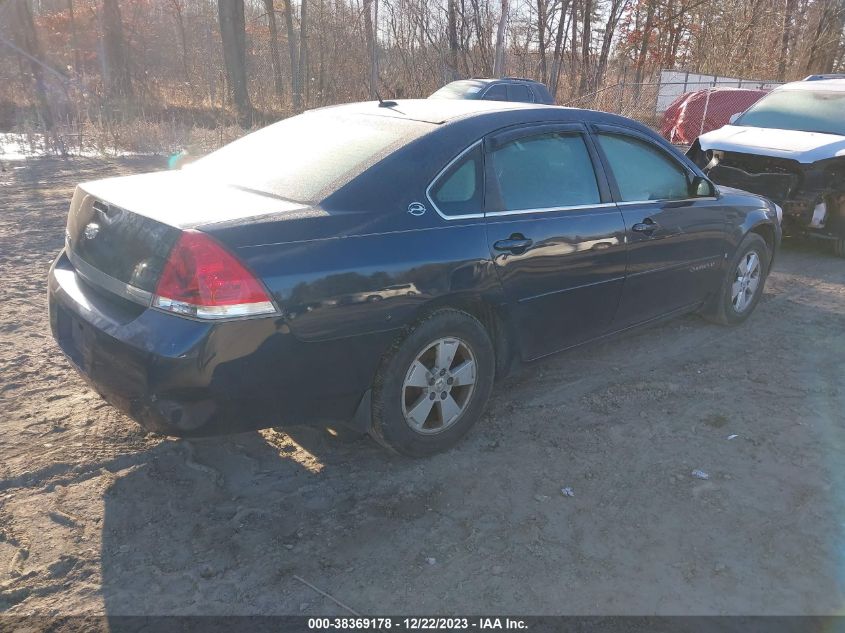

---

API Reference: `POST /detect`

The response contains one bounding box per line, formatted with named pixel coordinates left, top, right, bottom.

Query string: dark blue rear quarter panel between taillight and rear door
left=231, top=223, right=499, bottom=341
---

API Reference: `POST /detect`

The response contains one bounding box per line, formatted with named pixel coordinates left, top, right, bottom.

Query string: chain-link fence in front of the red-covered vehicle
left=561, top=80, right=780, bottom=146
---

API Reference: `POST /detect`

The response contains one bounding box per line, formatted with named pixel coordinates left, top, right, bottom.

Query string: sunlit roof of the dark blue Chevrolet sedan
left=310, top=99, right=557, bottom=125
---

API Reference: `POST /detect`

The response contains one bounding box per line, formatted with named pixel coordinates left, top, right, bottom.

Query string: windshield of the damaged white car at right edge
left=736, top=90, right=845, bottom=136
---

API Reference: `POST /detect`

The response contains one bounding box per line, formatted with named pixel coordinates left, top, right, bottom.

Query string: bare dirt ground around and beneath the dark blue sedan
left=0, top=158, right=845, bottom=615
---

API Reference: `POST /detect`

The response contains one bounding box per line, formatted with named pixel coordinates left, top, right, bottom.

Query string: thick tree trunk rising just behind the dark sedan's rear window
left=217, top=0, right=253, bottom=127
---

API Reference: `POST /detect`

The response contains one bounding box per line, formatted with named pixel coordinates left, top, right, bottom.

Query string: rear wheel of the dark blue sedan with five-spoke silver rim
left=370, top=309, right=496, bottom=457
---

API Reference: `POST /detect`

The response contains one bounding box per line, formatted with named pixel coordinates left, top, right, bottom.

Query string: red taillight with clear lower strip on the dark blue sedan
left=153, top=231, right=276, bottom=319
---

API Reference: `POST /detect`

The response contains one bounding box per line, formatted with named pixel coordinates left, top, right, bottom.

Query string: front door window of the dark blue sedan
left=598, top=134, right=690, bottom=202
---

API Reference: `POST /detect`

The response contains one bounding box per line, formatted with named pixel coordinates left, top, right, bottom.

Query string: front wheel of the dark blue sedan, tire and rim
left=706, top=233, right=771, bottom=325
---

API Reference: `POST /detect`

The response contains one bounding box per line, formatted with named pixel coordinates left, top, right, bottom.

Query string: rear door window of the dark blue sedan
left=492, top=133, right=601, bottom=211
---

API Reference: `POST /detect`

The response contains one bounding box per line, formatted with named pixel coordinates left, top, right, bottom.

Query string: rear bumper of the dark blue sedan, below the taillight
left=48, top=253, right=389, bottom=435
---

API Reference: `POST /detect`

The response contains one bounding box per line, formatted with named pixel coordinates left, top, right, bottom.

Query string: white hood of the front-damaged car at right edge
left=698, top=125, right=845, bottom=164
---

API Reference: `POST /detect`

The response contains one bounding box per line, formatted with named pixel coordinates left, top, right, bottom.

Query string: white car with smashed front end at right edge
left=687, top=76, right=845, bottom=257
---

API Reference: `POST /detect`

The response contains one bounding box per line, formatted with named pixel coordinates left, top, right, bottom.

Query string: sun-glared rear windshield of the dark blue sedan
left=186, top=109, right=433, bottom=202
